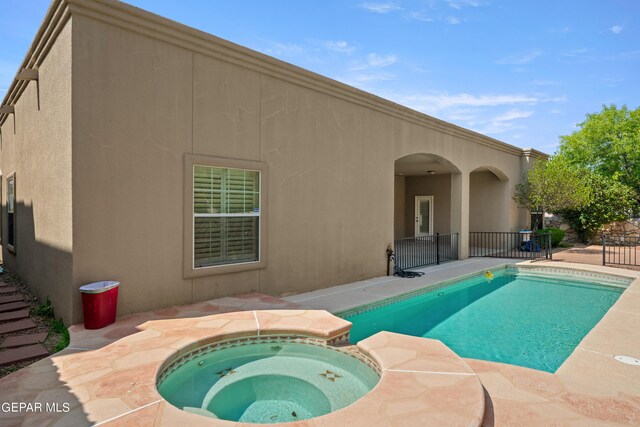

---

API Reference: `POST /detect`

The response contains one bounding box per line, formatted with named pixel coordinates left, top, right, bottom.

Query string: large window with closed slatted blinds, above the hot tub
left=193, top=164, right=260, bottom=268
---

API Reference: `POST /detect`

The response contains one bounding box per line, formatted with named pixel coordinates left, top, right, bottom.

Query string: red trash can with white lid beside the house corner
left=80, top=280, right=120, bottom=329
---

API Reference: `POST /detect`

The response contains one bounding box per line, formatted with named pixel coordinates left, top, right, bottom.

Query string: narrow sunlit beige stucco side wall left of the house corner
left=0, top=21, right=73, bottom=322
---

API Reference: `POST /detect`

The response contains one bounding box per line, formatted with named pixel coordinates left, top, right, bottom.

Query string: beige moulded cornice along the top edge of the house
left=0, top=0, right=547, bottom=158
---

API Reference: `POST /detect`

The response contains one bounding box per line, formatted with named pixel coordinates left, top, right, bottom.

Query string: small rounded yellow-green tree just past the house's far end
left=513, top=155, right=591, bottom=228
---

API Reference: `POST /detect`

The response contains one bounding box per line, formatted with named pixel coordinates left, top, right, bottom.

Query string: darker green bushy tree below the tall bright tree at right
left=560, top=173, right=637, bottom=243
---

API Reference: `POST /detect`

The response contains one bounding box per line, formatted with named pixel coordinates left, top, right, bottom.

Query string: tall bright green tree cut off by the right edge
left=559, top=104, right=640, bottom=203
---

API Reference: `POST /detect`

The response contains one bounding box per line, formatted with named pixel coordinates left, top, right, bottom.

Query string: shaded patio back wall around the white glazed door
left=403, top=174, right=451, bottom=237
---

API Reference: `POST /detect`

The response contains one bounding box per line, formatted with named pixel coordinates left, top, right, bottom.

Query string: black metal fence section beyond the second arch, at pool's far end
left=469, top=231, right=553, bottom=259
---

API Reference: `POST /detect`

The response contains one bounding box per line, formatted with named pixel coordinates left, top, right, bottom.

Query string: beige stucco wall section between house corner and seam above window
left=73, top=16, right=194, bottom=321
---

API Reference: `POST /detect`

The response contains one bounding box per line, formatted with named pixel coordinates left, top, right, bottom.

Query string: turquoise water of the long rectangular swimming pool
left=345, top=268, right=628, bottom=372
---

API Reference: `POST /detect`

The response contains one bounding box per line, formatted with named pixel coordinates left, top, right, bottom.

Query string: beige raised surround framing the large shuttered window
left=183, top=154, right=267, bottom=278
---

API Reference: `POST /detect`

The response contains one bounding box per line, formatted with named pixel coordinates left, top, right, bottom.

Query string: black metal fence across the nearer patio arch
left=394, top=233, right=458, bottom=270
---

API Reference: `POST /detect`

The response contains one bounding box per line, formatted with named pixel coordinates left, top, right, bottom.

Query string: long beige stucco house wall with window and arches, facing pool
left=3, top=2, right=536, bottom=321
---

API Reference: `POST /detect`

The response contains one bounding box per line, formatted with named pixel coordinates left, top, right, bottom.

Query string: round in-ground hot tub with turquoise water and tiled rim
left=157, top=336, right=380, bottom=423
